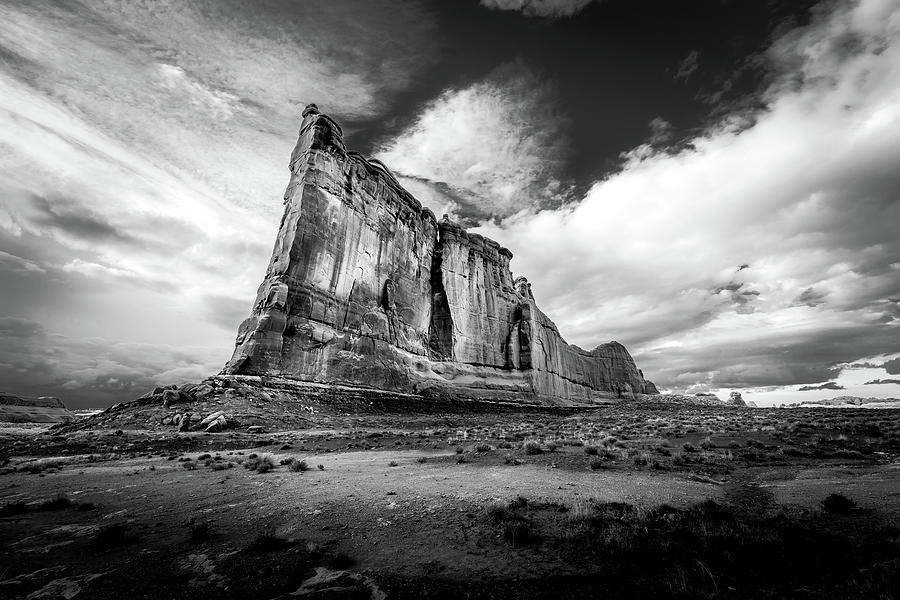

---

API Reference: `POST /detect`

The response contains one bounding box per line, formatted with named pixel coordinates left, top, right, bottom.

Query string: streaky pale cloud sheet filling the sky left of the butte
left=0, top=0, right=437, bottom=406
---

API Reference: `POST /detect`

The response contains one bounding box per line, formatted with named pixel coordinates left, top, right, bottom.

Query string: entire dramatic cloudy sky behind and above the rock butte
left=0, top=0, right=900, bottom=408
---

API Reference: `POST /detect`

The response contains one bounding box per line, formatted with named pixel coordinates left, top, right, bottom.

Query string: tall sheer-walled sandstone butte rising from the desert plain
left=224, top=104, right=656, bottom=403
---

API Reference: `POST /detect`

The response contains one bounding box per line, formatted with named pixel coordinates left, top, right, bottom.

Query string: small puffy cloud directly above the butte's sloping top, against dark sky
left=377, top=62, right=568, bottom=221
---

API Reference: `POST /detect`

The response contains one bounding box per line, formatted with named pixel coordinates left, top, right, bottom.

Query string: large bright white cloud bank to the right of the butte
left=481, top=0, right=900, bottom=387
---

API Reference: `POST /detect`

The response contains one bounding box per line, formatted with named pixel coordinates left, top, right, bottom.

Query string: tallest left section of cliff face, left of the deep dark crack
left=226, top=109, right=437, bottom=387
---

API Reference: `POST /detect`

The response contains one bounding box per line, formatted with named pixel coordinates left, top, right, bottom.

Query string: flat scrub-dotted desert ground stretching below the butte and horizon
left=0, top=386, right=900, bottom=599
